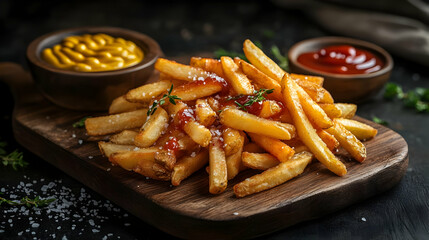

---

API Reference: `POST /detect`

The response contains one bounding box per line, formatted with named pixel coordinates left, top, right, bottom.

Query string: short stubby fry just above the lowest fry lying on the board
left=241, top=152, right=280, bottom=171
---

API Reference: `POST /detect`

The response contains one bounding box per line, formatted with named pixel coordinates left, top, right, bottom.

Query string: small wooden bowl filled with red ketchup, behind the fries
left=288, top=37, right=393, bottom=103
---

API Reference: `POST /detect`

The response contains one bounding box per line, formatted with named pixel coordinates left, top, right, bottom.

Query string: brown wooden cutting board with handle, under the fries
left=0, top=63, right=408, bottom=239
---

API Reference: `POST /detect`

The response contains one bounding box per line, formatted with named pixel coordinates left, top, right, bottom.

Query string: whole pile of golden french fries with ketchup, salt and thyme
left=85, top=40, right=377, bottom=197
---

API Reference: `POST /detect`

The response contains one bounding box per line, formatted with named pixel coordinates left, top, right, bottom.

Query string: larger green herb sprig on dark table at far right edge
left=384, top=83, right=429, bottom=113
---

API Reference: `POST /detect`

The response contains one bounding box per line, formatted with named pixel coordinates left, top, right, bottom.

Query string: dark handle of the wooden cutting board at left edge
left=0, top=62, right=35, bottom=106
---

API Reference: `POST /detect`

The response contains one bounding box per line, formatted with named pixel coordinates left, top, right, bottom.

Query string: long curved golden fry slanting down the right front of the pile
left=281, top=74, right=347, bottom=176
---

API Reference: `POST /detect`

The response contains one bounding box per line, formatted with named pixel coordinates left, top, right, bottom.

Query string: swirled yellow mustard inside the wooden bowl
left=42, top=33, right=144, bottom=72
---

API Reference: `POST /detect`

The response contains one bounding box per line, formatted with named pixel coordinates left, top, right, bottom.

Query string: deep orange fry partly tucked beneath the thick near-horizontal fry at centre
left=248, top=133, right=295, bottom=162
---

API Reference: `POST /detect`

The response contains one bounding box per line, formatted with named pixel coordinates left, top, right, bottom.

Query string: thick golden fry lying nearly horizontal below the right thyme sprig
left=219, top=108, right=295, bottom=140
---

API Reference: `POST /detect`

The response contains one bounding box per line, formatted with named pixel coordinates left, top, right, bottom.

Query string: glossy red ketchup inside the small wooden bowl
left=298, top=45, right=384, bottom=74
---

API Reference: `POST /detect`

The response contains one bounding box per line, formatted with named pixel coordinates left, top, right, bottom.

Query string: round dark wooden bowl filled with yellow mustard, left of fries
left=27, top=27, right=162, bottom=111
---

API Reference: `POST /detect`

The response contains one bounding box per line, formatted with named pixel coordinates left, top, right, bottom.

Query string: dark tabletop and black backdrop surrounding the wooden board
left=0, top=0, right=429, bottom=239
